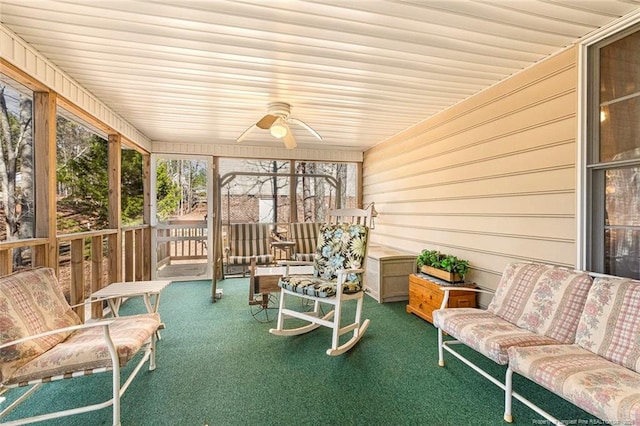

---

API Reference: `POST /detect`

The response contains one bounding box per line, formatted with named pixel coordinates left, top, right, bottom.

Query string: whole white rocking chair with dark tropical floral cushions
left=269, top=209, right=371, bottom=355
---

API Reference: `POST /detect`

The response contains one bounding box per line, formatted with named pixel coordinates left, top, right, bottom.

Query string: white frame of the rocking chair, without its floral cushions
left=269, top=209, right=371, bottom=356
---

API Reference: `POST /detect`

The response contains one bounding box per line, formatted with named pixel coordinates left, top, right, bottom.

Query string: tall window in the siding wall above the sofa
left=587, top=26, right=640, bottom=278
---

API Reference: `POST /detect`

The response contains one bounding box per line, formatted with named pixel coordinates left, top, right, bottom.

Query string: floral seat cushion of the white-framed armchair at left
left=7, top=313, right=160, bottom=384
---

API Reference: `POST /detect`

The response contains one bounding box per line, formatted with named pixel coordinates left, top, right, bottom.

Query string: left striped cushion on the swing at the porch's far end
left=227, top=223, right=273, bottom=265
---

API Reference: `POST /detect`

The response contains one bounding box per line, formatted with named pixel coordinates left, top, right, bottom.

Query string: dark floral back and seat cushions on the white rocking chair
left=278, top=224, right=368, bottom=297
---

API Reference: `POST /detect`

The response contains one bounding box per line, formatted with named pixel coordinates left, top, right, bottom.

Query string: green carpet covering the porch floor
left=2, top=279, right=600, bottom=426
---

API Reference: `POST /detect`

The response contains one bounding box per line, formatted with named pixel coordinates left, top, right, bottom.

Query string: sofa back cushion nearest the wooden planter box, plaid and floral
left=487, top=263, right=592, bottom=343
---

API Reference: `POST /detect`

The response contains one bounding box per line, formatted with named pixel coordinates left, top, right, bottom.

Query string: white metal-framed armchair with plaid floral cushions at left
left=0, top=268, right=160, bottom=425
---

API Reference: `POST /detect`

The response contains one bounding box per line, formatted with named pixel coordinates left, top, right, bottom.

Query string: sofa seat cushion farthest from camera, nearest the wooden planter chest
left=433, top=308, right=560, bottom=365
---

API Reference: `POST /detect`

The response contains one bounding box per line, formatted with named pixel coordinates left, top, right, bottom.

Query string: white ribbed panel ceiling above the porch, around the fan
left=0, top=0, right=640, bottom=152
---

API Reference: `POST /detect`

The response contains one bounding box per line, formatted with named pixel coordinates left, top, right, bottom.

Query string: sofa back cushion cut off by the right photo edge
left=576, top=277, right=640, bottom=372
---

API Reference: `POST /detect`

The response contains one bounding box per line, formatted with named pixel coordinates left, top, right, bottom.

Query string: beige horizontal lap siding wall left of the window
left=363, top=48, right=578, bottom=294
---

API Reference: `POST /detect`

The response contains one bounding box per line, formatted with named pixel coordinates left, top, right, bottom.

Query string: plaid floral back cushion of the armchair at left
left=0, top=268, right=81, bottom=383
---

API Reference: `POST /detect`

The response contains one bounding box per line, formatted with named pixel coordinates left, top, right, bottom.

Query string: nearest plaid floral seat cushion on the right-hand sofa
left=509, top=344, right=640, bottom=425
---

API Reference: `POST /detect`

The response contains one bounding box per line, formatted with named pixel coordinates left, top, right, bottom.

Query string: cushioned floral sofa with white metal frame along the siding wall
left=433, top=263, right=640, bottom=425
